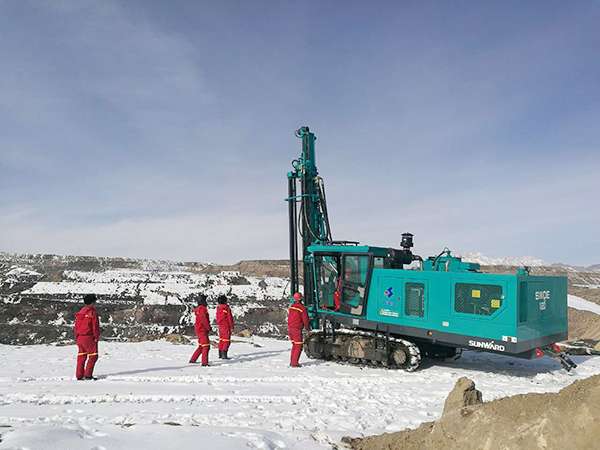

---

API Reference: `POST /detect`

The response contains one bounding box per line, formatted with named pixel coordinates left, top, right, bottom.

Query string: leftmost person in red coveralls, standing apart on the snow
left=75, top=294, right=100, bottom=380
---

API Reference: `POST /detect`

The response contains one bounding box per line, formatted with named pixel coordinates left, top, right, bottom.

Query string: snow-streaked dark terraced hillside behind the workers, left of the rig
left=0, top=253, right=289, bottom=344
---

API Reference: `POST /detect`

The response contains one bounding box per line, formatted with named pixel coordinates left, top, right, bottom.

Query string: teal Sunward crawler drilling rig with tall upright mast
left=286, top=127, right=576, bottom=371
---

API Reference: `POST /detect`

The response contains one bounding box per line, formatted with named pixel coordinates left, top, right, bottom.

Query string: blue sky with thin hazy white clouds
left=0, top=0, right=600, bottom=265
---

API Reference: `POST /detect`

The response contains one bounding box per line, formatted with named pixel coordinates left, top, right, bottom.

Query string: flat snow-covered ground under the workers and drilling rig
left=0, top=337, right=600, bottom=450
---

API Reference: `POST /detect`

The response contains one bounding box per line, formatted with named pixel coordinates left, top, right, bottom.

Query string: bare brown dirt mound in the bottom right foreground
left=347, top=375, right=600, bottom=450
